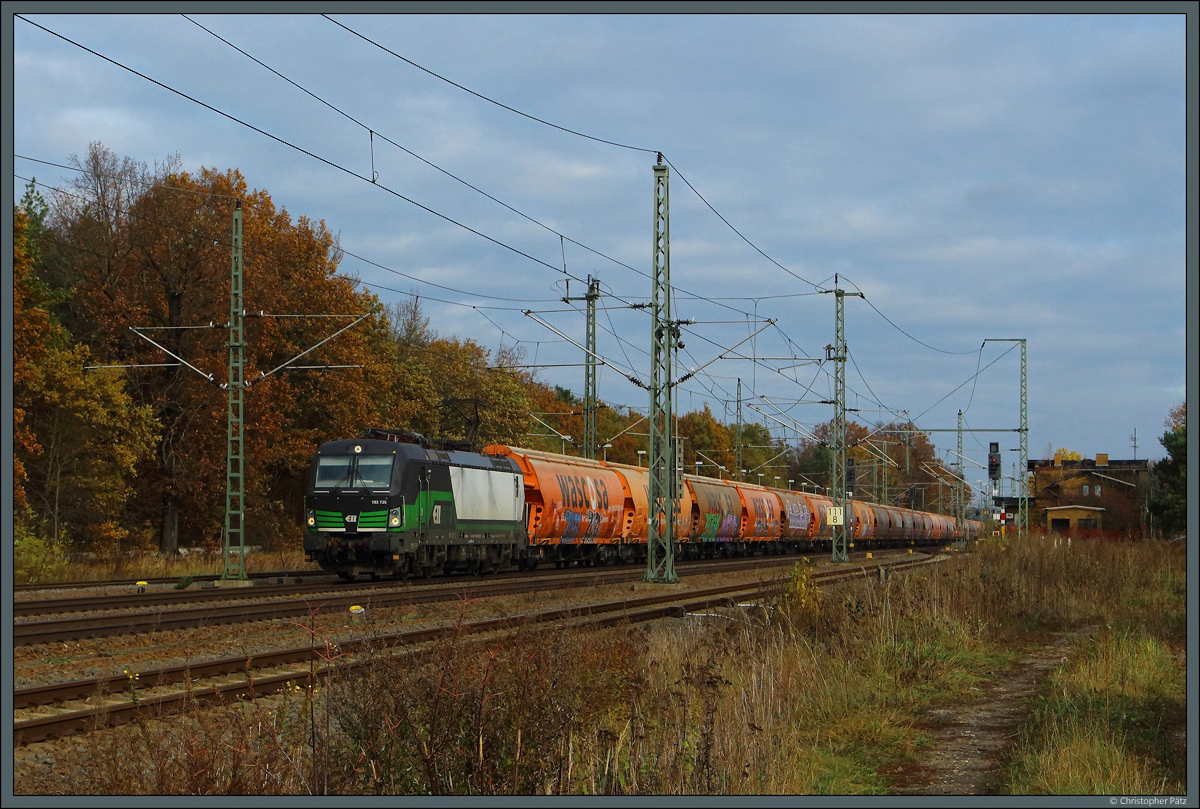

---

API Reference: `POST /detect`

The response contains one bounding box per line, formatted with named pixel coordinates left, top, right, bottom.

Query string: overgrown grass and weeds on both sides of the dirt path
left=17, top=528, right=1184, bottom=795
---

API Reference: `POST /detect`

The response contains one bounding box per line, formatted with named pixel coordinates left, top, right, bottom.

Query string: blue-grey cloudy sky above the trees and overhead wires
left=5, top=4, right=1194, bottom=481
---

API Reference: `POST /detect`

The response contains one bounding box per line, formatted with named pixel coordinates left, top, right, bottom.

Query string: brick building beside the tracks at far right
left=1028, top=446, right=1150, bottom=535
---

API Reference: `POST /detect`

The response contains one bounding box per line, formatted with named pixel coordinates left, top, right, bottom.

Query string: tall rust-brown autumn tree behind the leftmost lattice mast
left=43, top=144, right=401, bottom=552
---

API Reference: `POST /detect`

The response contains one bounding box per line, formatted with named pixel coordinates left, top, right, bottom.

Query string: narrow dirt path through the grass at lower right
left=888, top=634, right=1072, bottom=795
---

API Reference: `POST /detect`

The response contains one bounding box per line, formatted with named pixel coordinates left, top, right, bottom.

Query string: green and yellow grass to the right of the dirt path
left=993, top=532, right=1188, bottom=795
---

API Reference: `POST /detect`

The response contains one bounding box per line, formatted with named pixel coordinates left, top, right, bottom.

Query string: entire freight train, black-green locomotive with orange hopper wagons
left=304, top=427, right=979, bottom=579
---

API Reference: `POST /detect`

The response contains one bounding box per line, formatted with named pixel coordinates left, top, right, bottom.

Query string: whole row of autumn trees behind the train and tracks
left=13, top=144, right=950, bottom=553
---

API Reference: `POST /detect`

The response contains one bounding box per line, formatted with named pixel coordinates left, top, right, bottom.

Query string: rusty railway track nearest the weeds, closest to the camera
left=13, top=547, right=936, bottom=745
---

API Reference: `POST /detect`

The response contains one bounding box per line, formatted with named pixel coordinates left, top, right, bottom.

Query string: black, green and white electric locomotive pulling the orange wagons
left=304, top=427, right=526, bottom=579
